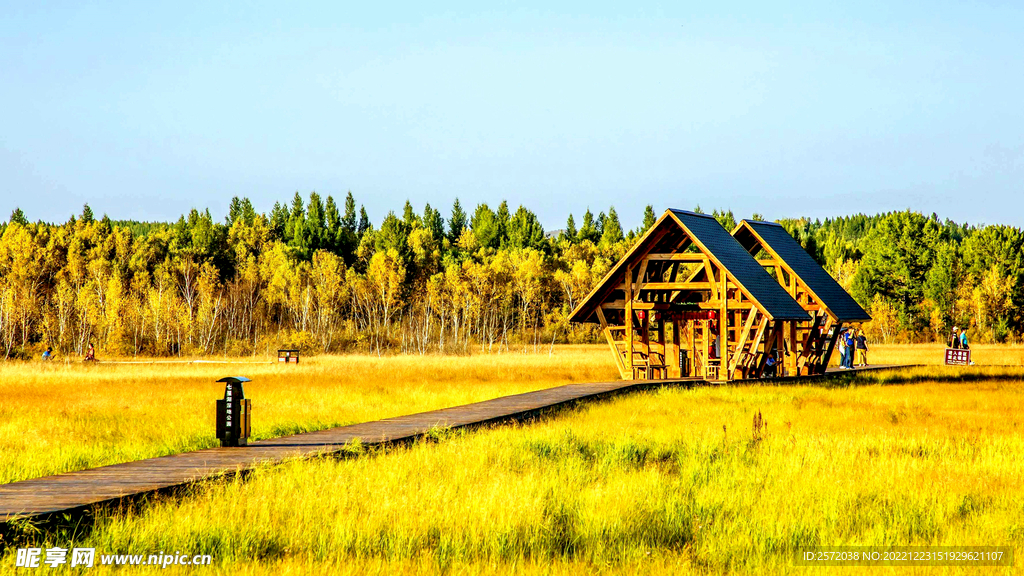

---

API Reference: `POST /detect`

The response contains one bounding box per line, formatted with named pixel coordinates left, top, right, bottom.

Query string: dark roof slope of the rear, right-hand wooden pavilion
left=736, top=220, right=871, bottom=322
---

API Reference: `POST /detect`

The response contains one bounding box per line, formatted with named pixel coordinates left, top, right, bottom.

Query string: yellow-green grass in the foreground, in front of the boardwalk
left=0, top=342, right=1024, bottom=574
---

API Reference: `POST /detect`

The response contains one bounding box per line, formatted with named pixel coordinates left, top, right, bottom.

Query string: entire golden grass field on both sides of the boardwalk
left=0, top=346, right=1024, bottom=574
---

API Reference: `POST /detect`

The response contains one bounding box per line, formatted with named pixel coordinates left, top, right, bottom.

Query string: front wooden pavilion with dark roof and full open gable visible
left=569, top=210, right=811, bottom=381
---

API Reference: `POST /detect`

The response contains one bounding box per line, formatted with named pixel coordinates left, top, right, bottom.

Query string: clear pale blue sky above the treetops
left=0, top=0, right=1024, bottom=229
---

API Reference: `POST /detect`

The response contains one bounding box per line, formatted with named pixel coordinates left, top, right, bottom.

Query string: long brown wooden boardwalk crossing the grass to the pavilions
left=0, top=366, right=913, bottom=523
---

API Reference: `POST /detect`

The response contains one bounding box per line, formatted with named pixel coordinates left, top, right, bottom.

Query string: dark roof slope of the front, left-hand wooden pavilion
left=672, top=209, right=810, bottom=320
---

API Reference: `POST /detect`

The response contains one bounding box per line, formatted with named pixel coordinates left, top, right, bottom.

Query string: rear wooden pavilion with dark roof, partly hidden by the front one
left=732, top=220, right=871, bottom=375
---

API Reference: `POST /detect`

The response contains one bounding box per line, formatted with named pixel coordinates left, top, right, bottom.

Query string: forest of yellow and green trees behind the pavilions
left=0, top=192, right=1024, bottom=359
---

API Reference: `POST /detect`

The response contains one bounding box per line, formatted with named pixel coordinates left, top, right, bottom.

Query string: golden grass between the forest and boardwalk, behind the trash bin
left=0, top=346, right=617, bottom=484
